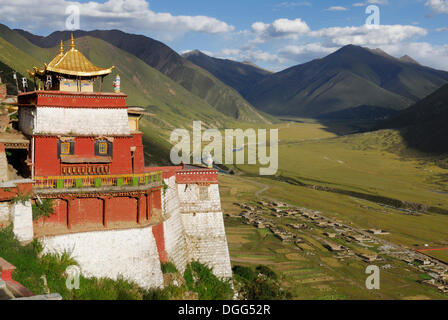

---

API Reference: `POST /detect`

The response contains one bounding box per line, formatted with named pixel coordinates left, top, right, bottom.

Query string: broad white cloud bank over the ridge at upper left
left=0, top=0, right=234, bottom=38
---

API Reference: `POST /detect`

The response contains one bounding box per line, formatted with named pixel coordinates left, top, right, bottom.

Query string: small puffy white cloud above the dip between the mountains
left=252, top=18, right=310, bottom=42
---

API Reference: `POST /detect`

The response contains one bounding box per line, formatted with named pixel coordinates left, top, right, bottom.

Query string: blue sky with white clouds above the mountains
left=0, top=0, right=448, bottom=71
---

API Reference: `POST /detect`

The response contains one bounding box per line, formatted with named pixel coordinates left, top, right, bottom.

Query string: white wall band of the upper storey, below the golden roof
left=19, top=107, right=130, bottom=135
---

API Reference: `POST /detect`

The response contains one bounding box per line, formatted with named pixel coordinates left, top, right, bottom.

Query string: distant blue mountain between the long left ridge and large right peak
left=182, top=50, right=272, bottom=96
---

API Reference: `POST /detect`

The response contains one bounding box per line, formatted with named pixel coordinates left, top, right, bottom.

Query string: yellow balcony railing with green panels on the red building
left=34, top=171, right=162, bottom=189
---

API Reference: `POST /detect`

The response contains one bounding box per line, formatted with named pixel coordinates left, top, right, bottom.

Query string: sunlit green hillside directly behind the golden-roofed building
left=0, top=30, right=245, bottom=164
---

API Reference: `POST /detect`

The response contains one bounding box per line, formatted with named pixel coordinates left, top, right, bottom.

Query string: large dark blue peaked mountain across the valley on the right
left=240, top=45, right=448, bottom=117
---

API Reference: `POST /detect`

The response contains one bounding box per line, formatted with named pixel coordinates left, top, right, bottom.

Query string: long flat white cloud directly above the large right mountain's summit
left=308, top=25, right=428, bottom=46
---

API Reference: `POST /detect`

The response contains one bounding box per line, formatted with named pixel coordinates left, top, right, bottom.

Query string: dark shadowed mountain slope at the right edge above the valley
left=380, top=84, right=448, bottom=154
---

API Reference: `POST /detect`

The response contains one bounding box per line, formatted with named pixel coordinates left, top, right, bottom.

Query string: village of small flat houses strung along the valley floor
left=234, top=201, right=448, bottom=293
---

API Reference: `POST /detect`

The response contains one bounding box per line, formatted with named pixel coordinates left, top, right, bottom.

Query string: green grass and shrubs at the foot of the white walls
left=0, top=226, right=233, bottom=300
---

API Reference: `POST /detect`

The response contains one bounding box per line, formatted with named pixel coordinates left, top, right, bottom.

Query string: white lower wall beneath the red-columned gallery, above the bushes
left=41, top=227, right=163, bottom=288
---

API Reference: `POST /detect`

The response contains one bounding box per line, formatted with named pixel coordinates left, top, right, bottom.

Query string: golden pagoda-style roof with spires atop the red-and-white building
left=30, top=34, right=114, bottom=77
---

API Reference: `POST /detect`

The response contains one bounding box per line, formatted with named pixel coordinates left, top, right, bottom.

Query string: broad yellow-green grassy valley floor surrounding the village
left=220, top=122, right=448, bottom=299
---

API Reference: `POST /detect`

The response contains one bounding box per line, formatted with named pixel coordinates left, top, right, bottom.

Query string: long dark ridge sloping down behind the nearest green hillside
left=15, top=30, right=272, bottom=123
